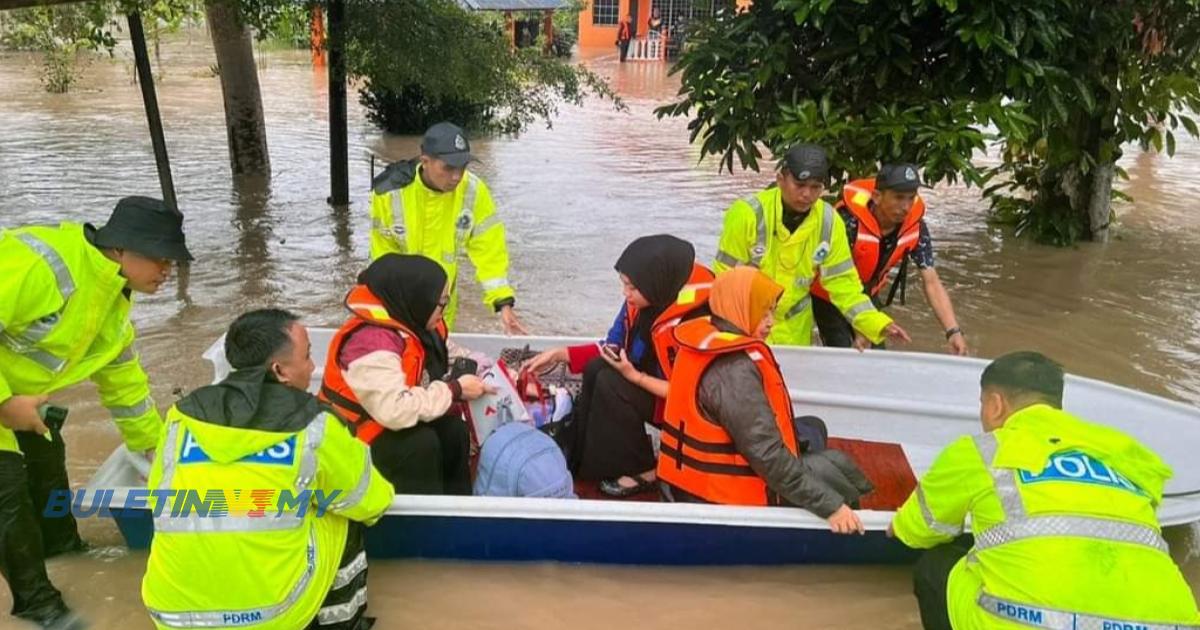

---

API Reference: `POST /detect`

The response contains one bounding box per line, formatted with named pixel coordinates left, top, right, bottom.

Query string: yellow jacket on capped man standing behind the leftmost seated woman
left=371, top=162, right=515, bottom=329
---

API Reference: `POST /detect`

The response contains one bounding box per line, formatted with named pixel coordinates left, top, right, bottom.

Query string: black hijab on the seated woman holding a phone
left=613, top=234, right=696, bottom=362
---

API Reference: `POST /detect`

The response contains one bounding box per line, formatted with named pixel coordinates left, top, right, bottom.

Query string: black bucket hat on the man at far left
left=92, top=197, right=192, bottom=260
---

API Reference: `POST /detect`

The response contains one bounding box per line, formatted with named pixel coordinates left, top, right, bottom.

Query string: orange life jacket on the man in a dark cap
left=812, top=179, right=925, bottom=300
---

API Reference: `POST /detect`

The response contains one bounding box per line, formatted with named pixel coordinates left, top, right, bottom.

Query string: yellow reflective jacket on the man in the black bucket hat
left=0, top=223, right=162, bottom=451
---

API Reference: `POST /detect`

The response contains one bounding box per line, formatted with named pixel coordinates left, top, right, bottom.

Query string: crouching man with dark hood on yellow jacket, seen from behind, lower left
left=142, top=308, right=394, bottom=630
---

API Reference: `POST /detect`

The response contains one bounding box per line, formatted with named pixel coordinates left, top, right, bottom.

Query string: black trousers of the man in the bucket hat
left=0, top=448, right=69, bottom=624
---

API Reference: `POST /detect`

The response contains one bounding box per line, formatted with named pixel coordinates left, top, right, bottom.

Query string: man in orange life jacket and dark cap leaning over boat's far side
left=812, top=164, right=967, bottom=355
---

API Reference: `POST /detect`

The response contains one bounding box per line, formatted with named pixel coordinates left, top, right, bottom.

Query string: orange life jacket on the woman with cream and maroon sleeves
left=317, top=284, right=446, bottom=444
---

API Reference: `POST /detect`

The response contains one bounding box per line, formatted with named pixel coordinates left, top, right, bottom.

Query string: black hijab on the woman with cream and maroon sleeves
left=359, top=253, right=450, bottom=379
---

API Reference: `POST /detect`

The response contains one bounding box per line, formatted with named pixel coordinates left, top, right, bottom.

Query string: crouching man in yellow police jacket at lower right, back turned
left=889, top=352, right=1200, bottom=630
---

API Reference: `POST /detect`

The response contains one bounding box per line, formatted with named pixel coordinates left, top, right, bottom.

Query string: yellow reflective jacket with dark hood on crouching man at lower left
left=142, top=371, right=394, bottom=630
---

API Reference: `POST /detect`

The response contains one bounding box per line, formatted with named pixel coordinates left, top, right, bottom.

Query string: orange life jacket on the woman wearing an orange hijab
left=658, top=318, right=799, bottom=505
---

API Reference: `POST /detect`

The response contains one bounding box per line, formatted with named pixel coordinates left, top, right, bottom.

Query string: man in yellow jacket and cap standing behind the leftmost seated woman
left=371, top=122, right=528, bottom=335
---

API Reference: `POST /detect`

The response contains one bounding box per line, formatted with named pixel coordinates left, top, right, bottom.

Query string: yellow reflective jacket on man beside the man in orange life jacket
left=713, top=187, right=892, bottom=346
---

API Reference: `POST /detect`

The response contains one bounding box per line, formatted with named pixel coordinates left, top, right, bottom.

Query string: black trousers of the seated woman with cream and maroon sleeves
left=371, top=414, right=470, bottom=494
